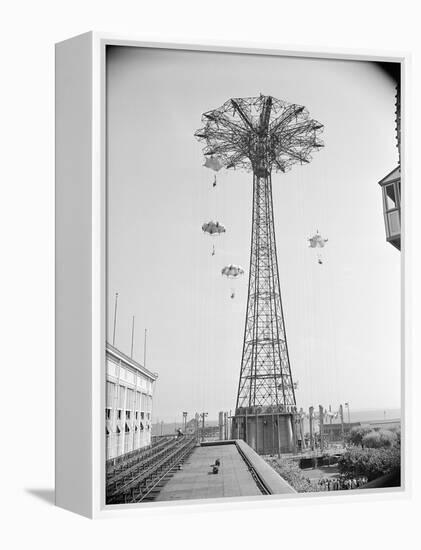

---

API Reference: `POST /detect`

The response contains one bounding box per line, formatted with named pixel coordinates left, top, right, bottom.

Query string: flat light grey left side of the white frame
left=55, top=33, right=95, bottom=517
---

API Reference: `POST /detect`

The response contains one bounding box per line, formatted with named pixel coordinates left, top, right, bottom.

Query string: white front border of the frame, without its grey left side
left=56, top=32, right=412, bottom=518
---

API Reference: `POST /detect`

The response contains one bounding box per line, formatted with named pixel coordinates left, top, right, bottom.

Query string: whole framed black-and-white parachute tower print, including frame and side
left=56, top=33, right=408, bottom=517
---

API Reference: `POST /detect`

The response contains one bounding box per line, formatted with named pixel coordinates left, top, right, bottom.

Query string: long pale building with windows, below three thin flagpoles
left=105, top=343, right=158, bottom=459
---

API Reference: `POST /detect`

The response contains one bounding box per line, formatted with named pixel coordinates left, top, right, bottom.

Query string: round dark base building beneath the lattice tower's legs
left=231, top=406, right=297, bottom=454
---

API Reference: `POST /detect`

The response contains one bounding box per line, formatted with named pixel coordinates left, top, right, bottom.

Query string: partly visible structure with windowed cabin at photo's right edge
left=379, top=63, right=401, bottom=250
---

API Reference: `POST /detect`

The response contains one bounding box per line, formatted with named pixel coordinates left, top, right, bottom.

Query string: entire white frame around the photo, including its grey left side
left=55, top=32, right=411, bottom=518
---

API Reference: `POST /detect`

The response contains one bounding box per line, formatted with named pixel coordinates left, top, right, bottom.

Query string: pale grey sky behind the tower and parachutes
left=107, top=47, right=400, bottom=421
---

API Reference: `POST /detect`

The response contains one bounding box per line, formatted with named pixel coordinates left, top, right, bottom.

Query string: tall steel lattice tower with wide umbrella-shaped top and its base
left=195, top=95, right=323, bottom=454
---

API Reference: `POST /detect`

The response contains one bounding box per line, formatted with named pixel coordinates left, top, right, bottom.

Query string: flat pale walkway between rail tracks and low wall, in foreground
left=156, top=445, right=262, bottom=501
